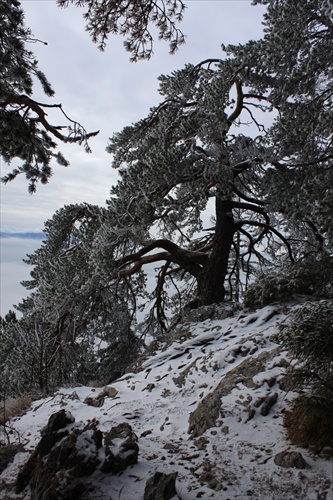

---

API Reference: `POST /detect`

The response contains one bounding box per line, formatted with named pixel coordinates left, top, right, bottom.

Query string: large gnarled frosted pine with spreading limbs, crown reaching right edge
left=87, top=0, right=333, bottom=318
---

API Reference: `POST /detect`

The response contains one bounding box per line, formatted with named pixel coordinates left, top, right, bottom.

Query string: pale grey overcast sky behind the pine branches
left=0, top=0, right=264, bottom=314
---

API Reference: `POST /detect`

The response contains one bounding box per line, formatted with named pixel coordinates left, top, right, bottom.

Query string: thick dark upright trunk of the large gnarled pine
left=198, top=197, right=235, bottom=305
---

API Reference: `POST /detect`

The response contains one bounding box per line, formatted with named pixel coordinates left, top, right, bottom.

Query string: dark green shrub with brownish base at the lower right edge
left=277, top=300, right=333, bottom=452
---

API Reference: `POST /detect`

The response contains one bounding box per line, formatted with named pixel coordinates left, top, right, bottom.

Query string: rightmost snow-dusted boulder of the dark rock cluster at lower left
left=101, top=422, right=139, bottom=474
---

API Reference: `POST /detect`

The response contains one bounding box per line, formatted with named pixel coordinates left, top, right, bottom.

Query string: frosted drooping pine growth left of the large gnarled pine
left=0, top=204, right=140, bottom=394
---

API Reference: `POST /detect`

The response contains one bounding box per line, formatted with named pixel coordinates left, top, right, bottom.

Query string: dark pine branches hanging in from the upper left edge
left=0, top=0, right=96, bottom=193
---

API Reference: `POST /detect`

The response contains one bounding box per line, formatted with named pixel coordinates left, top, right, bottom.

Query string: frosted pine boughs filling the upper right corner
left=227, top=0, right=333, bottom=246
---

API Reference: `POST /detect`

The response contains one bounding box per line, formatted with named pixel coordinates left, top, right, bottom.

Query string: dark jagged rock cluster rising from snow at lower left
left=16, top=410, right=139, bottom=500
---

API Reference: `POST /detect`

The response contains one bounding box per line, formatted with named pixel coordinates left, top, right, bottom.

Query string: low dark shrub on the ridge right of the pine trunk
left=244, top=257, right=333, bottom=308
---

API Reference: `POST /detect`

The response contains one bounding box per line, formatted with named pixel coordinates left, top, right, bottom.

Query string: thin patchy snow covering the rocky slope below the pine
left=0, top=306, right=333, bottom=500
